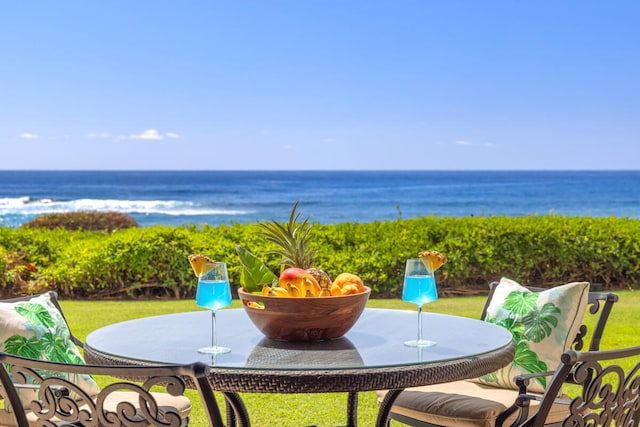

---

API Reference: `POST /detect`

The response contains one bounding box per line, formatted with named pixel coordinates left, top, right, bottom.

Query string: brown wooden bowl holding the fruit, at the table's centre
left=238, top=286, right=371, bottom=341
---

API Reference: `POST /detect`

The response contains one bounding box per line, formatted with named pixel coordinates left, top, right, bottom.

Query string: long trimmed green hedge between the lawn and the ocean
left=0, top=216, right=640, bottom=298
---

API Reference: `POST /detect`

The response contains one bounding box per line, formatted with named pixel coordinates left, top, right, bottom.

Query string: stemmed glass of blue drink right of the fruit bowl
left=402, top=258, right=438, bottom=347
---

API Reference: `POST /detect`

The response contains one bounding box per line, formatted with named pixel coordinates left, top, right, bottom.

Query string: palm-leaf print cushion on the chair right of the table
left=476, top=278, right=589, bottom=393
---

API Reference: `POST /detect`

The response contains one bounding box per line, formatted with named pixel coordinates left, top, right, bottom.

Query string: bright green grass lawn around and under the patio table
left=61, top=291, right=640, bottom=427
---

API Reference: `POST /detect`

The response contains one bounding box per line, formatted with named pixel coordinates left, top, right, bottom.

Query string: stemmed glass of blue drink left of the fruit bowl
left=196, top=262, right=231, bottom=354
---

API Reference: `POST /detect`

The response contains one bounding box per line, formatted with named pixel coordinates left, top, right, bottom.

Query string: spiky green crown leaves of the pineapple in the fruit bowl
left=258, top=202, right=315, bottom=269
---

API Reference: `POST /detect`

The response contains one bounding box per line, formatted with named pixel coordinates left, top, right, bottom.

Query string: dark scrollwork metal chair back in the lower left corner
left=0, top=352, right=224, bottom=427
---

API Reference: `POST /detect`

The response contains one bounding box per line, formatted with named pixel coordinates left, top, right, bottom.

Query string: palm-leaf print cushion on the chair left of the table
left=0, top=294, right=99, bottom=406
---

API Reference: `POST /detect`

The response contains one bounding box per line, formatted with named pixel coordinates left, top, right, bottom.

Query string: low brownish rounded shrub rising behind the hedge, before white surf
left=23, top=211, right=138, bottom=232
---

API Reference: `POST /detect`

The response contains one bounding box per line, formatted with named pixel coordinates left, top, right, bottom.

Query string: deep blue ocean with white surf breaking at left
left=0, top=171, right=640, bottom=231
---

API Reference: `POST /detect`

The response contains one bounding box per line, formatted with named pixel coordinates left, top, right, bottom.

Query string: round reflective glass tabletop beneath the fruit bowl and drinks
left=86, top=309, right=511, bottom=371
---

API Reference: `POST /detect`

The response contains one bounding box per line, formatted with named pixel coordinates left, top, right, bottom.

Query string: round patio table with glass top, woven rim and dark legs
left=85, top=308, right=514, bottom=427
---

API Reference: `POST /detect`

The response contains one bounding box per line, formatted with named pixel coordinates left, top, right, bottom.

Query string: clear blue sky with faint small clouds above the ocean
left=0, top=0, right=640, bottom=170
